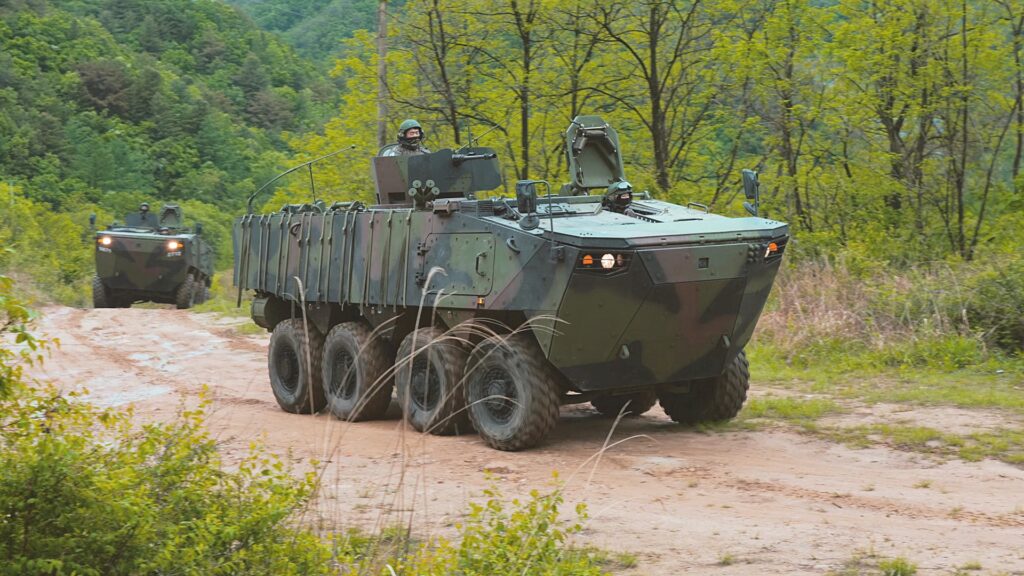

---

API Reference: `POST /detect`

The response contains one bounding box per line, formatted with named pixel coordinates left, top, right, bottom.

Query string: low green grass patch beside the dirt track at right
left=734, top=338, right=1024, bottom=464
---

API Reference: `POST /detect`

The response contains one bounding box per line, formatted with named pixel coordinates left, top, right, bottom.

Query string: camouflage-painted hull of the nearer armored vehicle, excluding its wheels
left=232, top=117, right=788, bottom=449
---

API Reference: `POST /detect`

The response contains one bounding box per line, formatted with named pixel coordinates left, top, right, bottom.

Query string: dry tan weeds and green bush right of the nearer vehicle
left=755, top=257, right=1024, bottom=369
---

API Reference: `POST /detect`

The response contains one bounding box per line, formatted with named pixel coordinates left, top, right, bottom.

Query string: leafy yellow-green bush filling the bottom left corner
left=0, top=387, right=330, bottom=575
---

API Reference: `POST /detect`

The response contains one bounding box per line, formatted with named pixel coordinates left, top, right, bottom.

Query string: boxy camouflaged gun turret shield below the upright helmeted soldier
left=373, top=147, right=502, bottom=204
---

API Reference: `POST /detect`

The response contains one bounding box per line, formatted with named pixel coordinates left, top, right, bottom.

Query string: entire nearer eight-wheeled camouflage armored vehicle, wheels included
left=233, top=116, right=788, bottom=450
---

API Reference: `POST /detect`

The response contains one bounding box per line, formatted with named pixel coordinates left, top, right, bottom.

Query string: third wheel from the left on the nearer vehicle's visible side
left=394, top=327, right=470, bottom=435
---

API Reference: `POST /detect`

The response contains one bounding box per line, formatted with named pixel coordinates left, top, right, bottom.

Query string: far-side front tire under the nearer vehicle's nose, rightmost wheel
left=657, top=352, right=751, bottom=424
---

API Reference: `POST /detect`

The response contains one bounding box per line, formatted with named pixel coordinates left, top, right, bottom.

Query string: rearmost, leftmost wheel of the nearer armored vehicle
left=267, top=318, right=325, bottom=414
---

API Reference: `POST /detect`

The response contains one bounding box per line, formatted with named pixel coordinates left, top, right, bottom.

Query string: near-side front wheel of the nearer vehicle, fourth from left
left=466, top=334, right=560, bottom=450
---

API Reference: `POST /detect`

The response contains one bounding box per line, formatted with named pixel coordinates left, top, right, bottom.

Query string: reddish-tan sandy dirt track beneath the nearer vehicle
left=24, top=307, right=1024, bottom=575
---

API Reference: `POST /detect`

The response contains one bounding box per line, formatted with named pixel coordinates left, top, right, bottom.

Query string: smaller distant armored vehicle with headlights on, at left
left=92, top=203, right=213, bottom=308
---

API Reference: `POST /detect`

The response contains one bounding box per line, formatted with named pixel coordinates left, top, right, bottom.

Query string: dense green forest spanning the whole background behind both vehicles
left=0, top=0, right=1024, bottom=347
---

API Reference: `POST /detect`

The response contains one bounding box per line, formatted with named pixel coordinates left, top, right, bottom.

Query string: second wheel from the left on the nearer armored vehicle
left=323, top=322, right=394, bottom=421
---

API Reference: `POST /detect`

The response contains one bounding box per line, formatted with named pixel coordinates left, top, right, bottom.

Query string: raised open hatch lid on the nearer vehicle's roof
left=565, top=116, right=626, bottom=194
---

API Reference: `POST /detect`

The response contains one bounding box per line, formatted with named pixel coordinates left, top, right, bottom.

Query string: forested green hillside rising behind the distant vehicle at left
left=0, top=0, right=336, bottom=291
